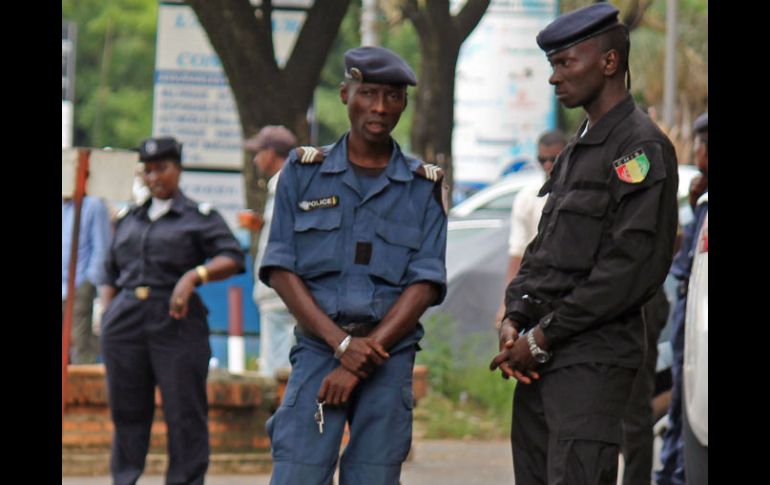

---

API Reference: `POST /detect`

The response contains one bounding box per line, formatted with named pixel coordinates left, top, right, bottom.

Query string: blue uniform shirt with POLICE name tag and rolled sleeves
left=259, top=134, right=447, bottom=323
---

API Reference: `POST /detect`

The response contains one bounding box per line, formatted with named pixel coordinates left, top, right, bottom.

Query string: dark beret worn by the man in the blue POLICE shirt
left=345, top=46, right=417, bottom=86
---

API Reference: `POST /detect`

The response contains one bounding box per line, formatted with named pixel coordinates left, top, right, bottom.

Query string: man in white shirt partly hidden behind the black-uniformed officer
left=495, top=130, right=567, bottom=327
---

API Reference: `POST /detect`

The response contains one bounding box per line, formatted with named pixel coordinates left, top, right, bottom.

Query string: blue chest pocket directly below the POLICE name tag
left=294, top=208, right=342, bottom=277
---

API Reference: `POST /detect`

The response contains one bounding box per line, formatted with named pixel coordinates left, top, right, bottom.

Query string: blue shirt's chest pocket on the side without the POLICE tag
left=369, top=219, right=421, bottom=285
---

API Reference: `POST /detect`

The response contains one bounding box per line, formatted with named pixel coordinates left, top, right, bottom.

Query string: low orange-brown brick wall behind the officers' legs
left=62, top=364, right=428, bottom=475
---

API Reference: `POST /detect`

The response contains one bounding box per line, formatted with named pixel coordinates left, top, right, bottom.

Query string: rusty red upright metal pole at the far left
left=61, top=149, right=91, bottom=416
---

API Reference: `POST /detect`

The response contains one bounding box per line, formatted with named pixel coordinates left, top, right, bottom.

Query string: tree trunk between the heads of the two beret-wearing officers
left=392, top=0, right=490, bottom=200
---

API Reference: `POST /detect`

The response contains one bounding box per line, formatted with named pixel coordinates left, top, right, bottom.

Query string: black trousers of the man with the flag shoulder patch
left=511, top=363, right=635, bottom=485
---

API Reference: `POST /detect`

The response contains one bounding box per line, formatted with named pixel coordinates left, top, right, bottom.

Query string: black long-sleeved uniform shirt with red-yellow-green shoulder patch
left=506, top=96, right=678, bottom=368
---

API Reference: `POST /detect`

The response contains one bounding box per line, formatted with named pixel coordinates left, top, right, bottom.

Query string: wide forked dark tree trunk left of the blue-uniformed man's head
left=187, top=0, right=350, bottom=253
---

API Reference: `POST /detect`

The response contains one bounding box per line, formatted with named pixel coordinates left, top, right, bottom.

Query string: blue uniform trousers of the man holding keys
left=266, top=333, right=417, bottom=485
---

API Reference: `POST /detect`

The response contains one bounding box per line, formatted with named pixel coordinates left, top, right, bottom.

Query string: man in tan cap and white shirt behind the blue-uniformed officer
left=244, top=126, right=297, bottom=377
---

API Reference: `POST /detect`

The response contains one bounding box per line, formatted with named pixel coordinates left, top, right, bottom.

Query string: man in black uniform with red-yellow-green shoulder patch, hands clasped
left=490, top=3, right=678, bottom=485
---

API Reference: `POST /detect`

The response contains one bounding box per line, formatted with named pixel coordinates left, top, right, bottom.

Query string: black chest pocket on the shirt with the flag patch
left=543, top=190, right=610, bottom=270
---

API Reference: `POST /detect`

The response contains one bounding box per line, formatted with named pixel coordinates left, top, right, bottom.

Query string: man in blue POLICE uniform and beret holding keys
left=259, top=47, right=447, bottom=485
